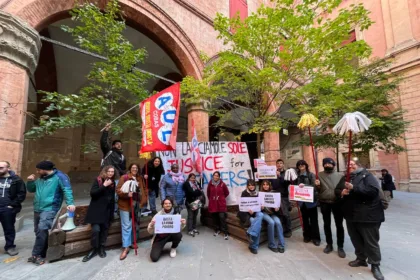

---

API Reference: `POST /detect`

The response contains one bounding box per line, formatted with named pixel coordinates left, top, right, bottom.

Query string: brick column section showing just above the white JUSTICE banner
left=187, top=100, right=210, bottom=142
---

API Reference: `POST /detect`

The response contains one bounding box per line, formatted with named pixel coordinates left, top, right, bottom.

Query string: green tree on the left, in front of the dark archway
left=26, top=0, right=149, bottom=140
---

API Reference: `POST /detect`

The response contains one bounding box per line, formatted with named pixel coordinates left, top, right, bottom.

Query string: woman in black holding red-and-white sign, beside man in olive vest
left=295, top=160, right=321, bottom=246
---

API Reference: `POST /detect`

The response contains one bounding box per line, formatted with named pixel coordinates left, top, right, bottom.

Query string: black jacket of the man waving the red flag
left=101, top=131, right=127, bottom=177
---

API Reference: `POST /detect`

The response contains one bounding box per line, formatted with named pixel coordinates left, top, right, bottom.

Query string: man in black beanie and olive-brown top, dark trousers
left=315, top=158, right=346, bottom=258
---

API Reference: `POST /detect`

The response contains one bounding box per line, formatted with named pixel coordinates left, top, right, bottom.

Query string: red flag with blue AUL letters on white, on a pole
left=140, top=83, right=180, bottom=153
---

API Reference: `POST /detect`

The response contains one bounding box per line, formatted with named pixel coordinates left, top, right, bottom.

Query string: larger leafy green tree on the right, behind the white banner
left=182, top=0, right=372, bottom=155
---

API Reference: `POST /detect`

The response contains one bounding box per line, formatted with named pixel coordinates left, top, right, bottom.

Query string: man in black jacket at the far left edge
left=0, top=161, right=26, bottom=256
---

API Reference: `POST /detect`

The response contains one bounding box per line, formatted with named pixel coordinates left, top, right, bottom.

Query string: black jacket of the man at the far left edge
left=0, top=171, right=26, bottom=213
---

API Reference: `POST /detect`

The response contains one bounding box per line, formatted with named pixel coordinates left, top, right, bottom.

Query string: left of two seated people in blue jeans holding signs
left=238, top=179, right=264, bottom=254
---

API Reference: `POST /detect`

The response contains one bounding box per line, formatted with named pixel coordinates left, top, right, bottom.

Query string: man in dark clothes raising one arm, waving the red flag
left=101, top=124, right=127, bottom=176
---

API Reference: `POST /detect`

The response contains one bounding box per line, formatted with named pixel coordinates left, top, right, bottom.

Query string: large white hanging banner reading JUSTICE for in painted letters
left=157, top=142, right=252, bottom=205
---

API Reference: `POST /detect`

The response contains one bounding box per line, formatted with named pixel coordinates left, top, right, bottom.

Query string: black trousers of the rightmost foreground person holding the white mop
left=346, top=221, right=381, bottom=264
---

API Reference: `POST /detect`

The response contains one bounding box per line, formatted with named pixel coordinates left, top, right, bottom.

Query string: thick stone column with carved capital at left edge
left=0, top=11, right=41, bottom=173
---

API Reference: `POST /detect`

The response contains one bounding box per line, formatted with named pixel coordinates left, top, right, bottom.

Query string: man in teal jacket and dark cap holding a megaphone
left=27, top=161, right=76, bottom=265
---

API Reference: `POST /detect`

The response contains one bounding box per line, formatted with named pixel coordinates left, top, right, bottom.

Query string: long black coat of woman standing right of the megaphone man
left=85, top=178, right=115, bottom=224
